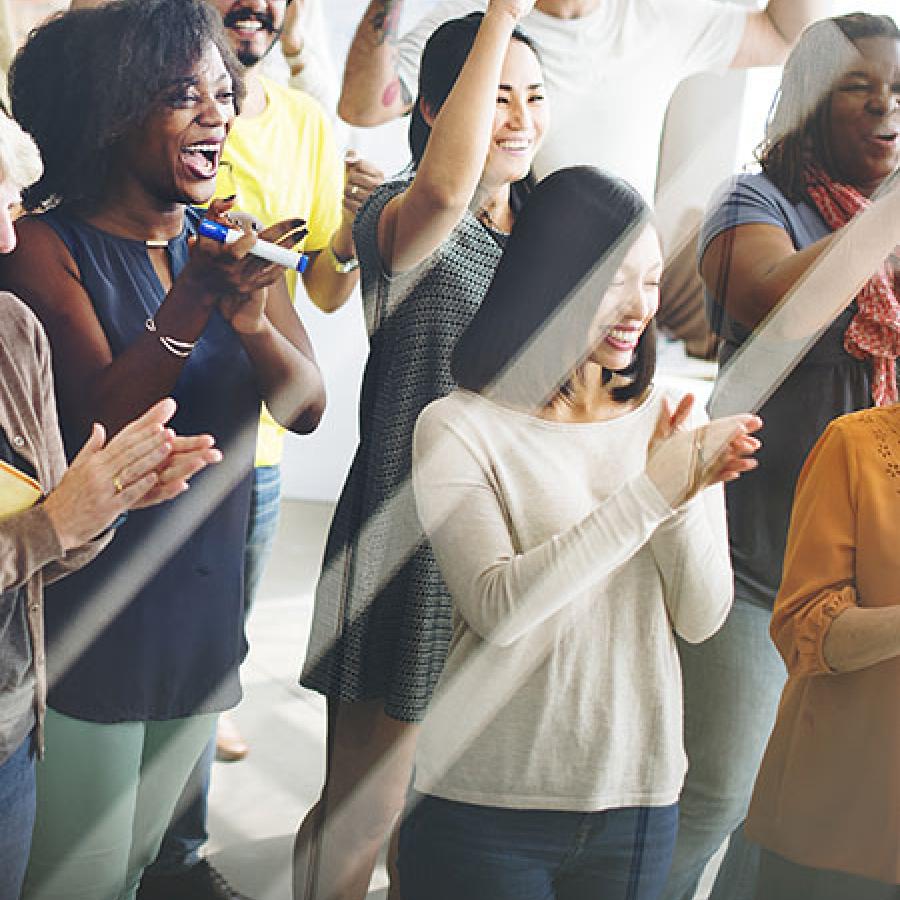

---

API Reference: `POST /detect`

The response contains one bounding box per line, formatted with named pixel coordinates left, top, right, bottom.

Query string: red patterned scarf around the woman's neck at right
left=806, top=166, right=900, bottom=406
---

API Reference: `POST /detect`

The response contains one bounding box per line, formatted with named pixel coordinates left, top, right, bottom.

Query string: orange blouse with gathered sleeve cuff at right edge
left=747, top=405, right=900, bottom=884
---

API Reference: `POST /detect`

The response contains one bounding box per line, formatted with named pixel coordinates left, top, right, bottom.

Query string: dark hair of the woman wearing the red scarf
left=756, top=12, right=900, bottom=202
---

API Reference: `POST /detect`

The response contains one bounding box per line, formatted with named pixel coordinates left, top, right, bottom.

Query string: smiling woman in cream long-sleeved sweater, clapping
left=399, top=167, right=760, bottom=900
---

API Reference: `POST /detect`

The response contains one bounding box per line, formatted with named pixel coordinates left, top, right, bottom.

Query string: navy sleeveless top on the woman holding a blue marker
left=42, top=210, right=260, bottom=722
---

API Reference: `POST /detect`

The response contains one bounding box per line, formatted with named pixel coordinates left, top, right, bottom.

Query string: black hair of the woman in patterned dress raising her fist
left=409, top=12, right=541, bottom=212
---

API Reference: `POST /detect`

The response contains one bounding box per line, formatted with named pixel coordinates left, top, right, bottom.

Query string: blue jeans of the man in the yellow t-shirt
left=147, top=466, right=281, bottom=877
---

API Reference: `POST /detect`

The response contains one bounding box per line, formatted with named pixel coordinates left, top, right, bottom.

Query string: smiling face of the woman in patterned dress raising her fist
left=484, top=40, right=550, bottom=186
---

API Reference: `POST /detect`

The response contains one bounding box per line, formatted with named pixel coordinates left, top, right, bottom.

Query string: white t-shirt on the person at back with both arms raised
left=399, top=0, right=747, bottom=201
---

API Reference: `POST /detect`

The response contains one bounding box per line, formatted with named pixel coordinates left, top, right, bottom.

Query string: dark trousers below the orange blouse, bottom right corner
left=756, top=850, right=900, bottom=900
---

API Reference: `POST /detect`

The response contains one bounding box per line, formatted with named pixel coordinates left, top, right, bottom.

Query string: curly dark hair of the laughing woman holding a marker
left=10, top=0, right=244, bottom=210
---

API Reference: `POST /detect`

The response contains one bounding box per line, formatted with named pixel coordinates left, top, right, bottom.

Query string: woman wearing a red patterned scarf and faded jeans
left=666, top=13, right=900, bottom=900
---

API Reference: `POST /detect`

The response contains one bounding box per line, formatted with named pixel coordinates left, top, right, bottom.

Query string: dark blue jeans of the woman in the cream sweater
left=398, top=796, right=678, bottom=900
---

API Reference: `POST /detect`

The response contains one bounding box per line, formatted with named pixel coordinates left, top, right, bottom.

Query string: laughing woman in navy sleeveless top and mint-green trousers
left=0, top=0, right=323, bottom=900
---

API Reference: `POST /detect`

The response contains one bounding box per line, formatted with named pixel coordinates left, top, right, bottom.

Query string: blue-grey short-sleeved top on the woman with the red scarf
left=700, top=174, right=872, bottom=608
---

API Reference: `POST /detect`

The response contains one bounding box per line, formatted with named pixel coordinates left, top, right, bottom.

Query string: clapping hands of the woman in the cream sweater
left=646, top=394, right=762, bottom=508
